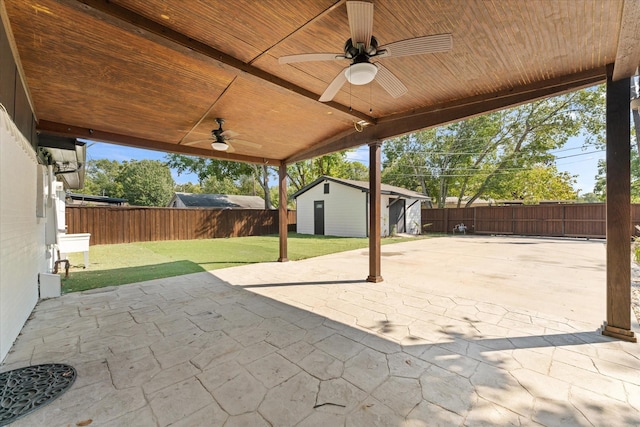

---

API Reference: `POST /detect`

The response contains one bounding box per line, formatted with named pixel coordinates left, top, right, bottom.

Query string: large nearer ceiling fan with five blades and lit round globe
left=278, top=1, right=453, bottom=102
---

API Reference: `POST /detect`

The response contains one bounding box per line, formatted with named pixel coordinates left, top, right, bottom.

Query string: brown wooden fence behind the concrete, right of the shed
left=422, top=203, right=640, bottom=238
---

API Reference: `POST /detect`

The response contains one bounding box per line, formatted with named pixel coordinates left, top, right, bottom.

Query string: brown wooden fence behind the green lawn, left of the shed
left=65, top=206, right=296, bottom=245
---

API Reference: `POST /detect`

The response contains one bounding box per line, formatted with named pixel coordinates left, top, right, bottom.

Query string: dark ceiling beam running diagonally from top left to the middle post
left=74, top=0, right=376, bottom=123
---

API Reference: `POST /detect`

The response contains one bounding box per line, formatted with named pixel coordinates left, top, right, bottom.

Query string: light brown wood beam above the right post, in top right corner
left=613, top=0, right=640, bottom=81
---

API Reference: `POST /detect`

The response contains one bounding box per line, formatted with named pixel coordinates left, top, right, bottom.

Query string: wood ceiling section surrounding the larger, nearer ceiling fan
left=268, top=0, right=622, bottom=118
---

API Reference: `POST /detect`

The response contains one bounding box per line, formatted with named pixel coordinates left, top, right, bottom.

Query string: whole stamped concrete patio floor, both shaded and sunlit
left=1, top=236, right=640, bottom=427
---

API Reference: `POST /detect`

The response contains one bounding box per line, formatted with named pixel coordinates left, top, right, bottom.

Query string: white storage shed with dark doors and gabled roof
left=293, top=176, right=430, bottom=237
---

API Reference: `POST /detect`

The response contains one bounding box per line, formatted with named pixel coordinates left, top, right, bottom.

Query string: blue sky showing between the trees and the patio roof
left=87, top=138, right=605, bottom=194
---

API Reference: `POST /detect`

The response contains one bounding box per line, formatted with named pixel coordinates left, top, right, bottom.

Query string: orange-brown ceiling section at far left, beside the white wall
left=7, top=0, right=234, bottom=142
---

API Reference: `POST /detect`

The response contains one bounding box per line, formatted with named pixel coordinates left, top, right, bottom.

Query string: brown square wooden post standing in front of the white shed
left=367, top=141, right=383, bottom=283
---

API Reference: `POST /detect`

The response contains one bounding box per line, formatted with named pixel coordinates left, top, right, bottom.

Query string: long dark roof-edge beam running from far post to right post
left=286, top=67, right=607, bottom=163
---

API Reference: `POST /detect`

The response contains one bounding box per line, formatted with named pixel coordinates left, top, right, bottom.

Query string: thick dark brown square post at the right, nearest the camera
left=602, top=65, right=636, bottom=342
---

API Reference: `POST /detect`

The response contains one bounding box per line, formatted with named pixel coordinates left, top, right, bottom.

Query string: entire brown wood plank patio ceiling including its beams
left=0, top=0, right=640, bottom=163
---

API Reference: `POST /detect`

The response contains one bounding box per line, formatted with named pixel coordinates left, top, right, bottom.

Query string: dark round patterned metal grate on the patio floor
left=0, top=363, right=77, bottom=426
